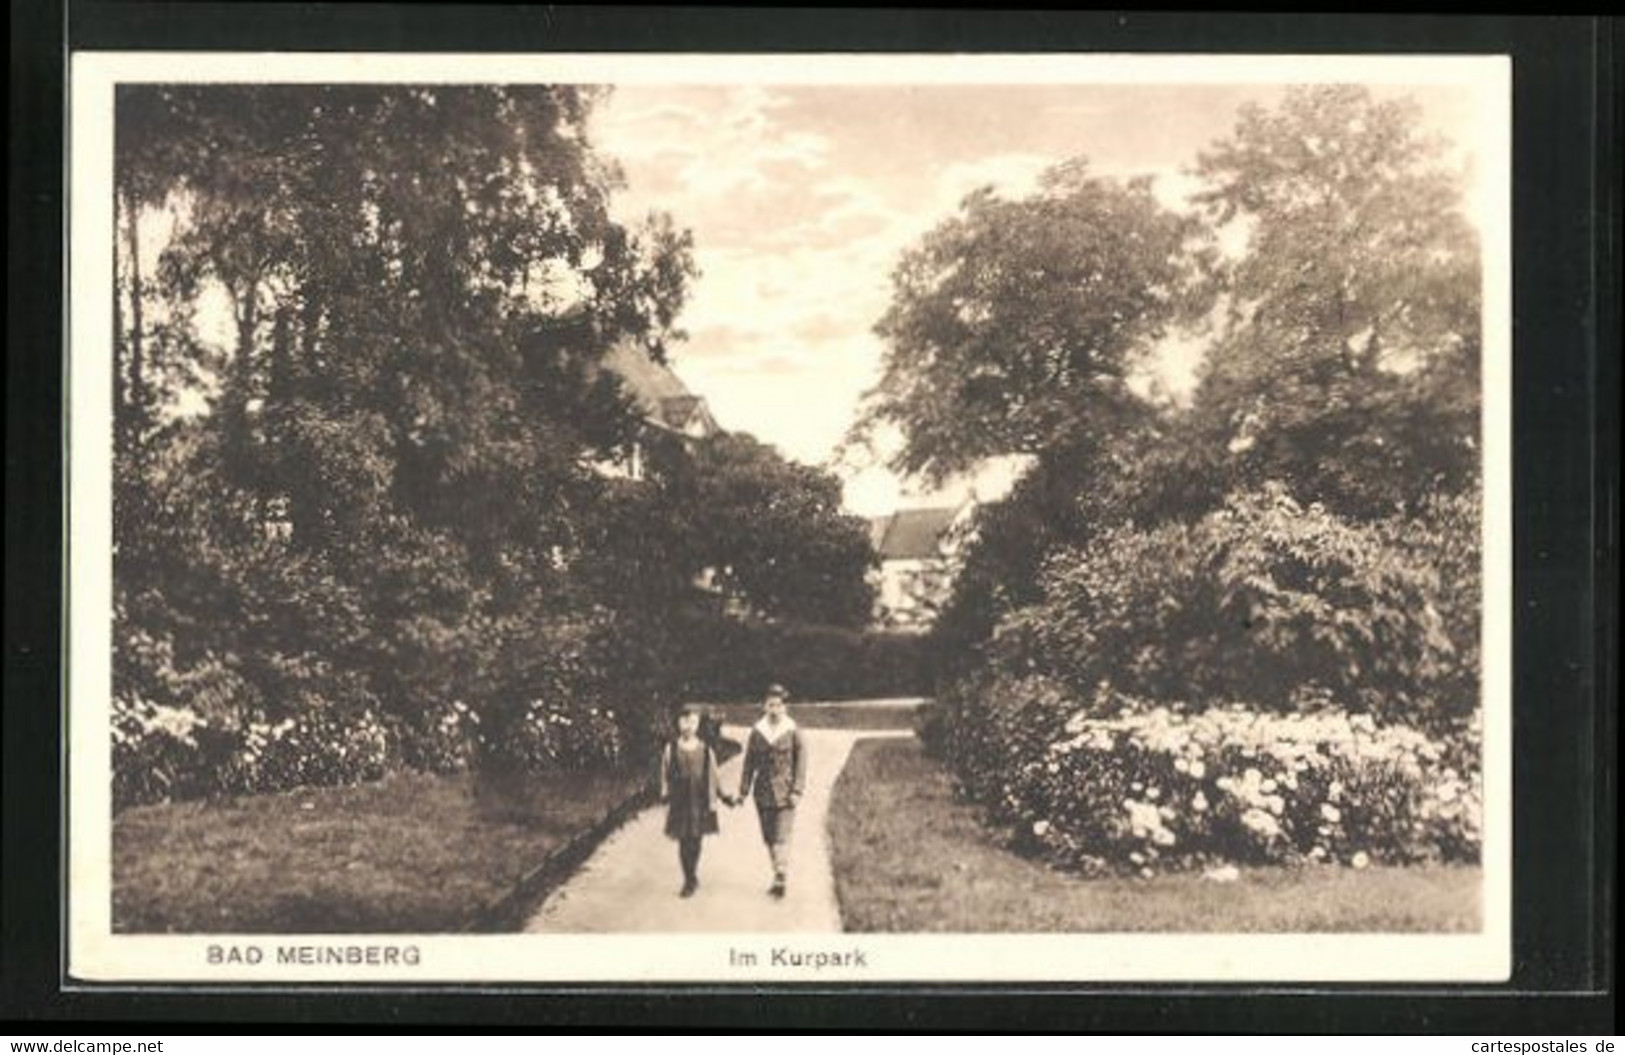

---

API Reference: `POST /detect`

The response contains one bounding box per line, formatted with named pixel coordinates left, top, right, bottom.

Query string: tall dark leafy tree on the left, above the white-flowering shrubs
left=115, top=85, right=691, bottom=757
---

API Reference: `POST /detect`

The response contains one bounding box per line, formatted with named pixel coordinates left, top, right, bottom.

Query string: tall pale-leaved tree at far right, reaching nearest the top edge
left=1183, top=86, right=1480, bottom=517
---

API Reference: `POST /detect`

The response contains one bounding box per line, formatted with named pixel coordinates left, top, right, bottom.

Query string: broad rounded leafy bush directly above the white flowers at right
left=993, top=486, right=1477, bottom=728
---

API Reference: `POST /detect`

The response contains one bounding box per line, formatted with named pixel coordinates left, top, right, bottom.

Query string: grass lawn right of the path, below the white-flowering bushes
left=829, top=740, right=1480, bottom=933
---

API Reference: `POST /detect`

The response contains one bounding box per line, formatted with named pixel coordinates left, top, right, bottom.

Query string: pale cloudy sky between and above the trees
left=590, top=83, right=1472, bottom=515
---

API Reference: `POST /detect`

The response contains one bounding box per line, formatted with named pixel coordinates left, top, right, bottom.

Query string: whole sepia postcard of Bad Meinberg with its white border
left=63, top=52, right=1513, bottom=987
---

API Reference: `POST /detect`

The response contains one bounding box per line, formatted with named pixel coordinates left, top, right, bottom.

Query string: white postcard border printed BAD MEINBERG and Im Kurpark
left=63, top=52, right=1513, bottom=983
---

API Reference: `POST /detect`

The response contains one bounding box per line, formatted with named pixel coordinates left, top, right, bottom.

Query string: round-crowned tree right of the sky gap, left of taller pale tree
left=853, top=159, right=1201, bottom=480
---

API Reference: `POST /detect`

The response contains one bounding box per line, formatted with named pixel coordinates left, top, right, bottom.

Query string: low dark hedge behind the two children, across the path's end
left=679, top=613, right=931, bottom=701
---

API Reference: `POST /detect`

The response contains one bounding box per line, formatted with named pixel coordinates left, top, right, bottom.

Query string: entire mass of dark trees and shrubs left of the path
left=114, top=85, right=897, bottom=803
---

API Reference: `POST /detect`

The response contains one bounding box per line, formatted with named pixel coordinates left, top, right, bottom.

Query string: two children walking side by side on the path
left=660, top=684, right=808, bottom=897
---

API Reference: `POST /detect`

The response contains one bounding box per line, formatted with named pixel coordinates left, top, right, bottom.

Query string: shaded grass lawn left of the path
left=112, top=772, right=645, bottom=933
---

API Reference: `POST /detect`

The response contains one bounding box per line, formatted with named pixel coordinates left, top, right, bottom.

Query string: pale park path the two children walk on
left=525, top=725, right=912, bottom=933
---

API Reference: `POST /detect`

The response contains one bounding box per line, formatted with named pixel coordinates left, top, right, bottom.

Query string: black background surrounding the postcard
left=0, top=0, right=1622, bottom=1035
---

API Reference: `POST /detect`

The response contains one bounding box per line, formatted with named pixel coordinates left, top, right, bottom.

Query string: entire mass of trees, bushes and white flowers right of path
left=897, top=86, right=1482, bottom=868
